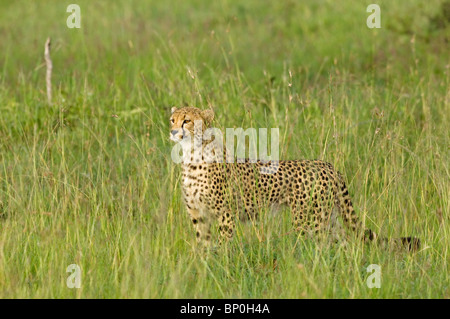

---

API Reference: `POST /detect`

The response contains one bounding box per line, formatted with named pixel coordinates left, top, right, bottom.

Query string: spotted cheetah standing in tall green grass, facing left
left=170, top=107, right=420, bottom=250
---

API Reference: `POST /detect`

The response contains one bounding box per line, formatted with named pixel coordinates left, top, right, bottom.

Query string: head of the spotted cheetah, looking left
left=170, top=107, right=214, bottom=142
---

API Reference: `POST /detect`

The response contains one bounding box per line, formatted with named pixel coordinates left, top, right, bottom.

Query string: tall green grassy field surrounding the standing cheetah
left=0, top=0, right=450, bottom=298
